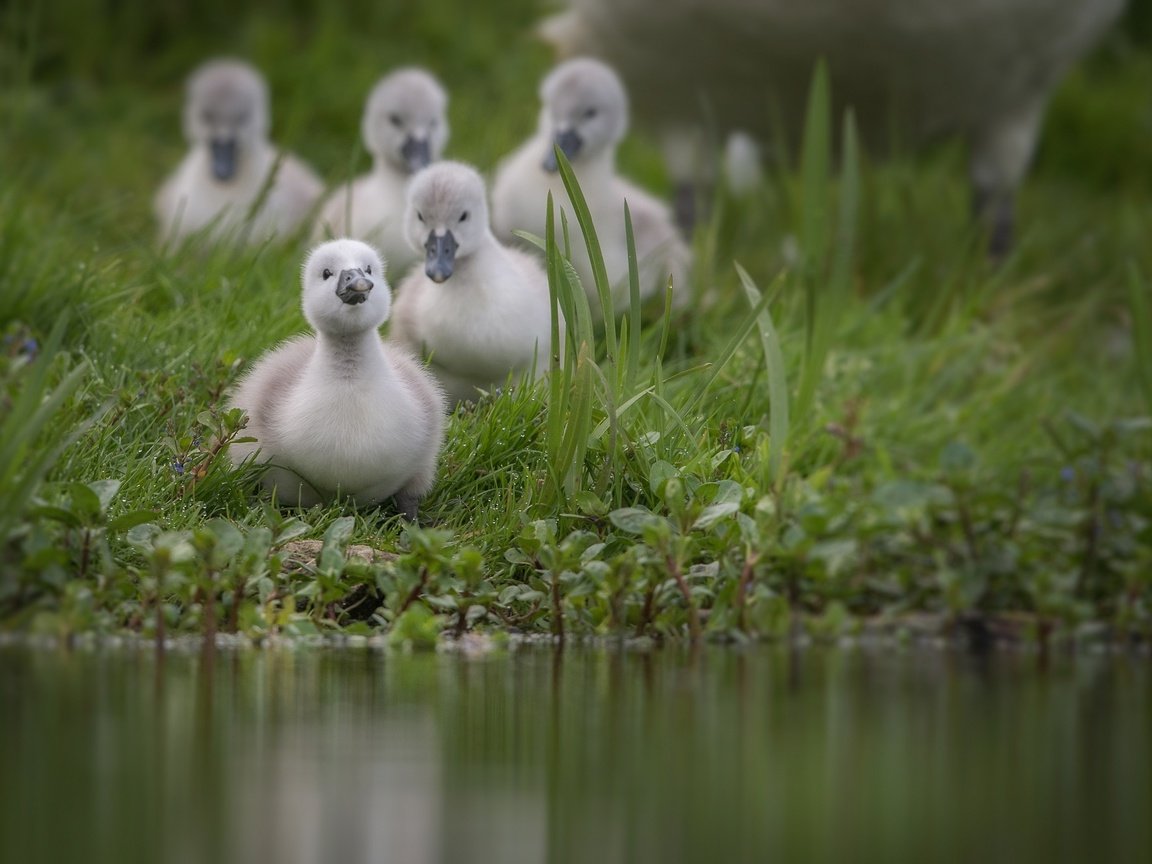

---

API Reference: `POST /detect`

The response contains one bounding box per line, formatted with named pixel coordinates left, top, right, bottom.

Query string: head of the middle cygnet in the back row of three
left=361, top=68, right=448, bottom=172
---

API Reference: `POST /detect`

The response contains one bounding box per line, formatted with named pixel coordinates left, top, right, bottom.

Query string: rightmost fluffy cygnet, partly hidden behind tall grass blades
left=492, top=59, right=691, bottom=322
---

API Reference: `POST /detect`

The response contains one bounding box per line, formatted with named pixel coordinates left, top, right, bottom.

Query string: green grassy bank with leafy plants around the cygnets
left=0, top=0, right=1152, bottom=644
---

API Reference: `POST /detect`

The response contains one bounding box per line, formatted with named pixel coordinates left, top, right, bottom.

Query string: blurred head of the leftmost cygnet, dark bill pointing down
left=184, top=60, right=268, bottom=183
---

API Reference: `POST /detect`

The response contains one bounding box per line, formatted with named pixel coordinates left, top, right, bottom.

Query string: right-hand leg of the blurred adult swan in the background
left=969, top=103, right=1044, bottom=260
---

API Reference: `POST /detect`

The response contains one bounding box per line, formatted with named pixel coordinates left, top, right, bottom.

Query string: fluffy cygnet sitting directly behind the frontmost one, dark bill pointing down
left=391, top=162, right=552, bottom=402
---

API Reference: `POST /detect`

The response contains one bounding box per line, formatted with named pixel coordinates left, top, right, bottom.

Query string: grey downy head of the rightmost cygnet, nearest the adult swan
left=540, top=58, right=628, bottom=172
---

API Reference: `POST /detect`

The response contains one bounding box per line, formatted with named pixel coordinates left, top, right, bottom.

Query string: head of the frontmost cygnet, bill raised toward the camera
left=301, top=240, right=392, bottom=336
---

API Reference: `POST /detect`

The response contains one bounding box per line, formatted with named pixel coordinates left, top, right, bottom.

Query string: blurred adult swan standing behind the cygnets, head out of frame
left=541, top=0, right=1124, bottom=252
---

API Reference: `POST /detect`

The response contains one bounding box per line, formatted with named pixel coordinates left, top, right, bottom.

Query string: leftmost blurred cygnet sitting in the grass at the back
left=156, top=60, right=324, bottom=243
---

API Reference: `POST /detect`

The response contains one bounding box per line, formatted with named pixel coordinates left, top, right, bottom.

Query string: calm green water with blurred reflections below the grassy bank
left=0, top=647, right=1152, bottom=864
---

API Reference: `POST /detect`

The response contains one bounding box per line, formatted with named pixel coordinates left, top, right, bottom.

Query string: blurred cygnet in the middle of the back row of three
left=316, top=68, right=448, bottom=273
